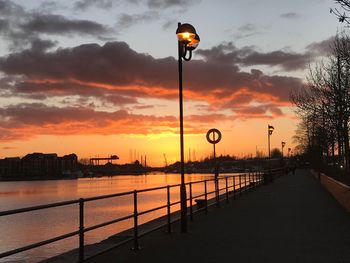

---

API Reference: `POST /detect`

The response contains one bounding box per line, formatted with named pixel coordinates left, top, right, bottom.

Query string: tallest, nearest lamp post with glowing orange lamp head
left=176, top=23, right=200, bottom=233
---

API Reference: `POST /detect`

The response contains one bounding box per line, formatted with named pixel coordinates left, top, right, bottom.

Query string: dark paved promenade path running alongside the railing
left=89, top=170, right=350, bottom=263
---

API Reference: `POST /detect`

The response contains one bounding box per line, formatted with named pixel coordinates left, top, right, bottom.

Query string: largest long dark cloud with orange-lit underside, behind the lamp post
left=0, top=42, right=301, bottom=110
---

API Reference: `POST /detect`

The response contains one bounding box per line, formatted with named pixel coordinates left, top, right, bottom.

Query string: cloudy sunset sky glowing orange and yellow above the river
left=0, top=0, right=343, bottom=165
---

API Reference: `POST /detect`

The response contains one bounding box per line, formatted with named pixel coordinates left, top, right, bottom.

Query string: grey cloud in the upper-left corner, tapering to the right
left=0, top=0, right=112, bottom=50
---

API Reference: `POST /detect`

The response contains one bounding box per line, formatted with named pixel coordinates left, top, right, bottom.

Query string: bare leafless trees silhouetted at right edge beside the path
left=291, top=33, right=350, bottom=171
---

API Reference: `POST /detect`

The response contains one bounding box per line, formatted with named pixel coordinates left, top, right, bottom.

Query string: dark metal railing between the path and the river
left=0, top=170, right=282, bottom=262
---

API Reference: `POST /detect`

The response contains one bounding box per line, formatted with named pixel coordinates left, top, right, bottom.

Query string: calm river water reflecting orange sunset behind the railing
left=0, top=174, right=243, bottom=263
